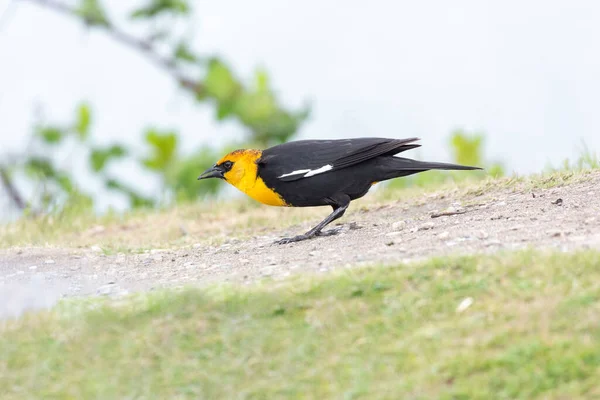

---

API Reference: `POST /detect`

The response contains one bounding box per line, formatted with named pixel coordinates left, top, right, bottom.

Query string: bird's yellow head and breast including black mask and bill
left=198, top=149, right=287, bottom=206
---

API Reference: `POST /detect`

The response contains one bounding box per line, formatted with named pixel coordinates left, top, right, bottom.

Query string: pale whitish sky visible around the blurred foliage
left=0, top=0, right=600, bottom=209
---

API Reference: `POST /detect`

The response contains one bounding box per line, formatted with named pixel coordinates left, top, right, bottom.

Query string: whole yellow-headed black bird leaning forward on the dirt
left=198, top=137, right=481, bottom=244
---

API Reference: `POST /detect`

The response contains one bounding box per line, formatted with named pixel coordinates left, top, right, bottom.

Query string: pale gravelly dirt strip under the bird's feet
left=0, top=173, right=600, bottom=317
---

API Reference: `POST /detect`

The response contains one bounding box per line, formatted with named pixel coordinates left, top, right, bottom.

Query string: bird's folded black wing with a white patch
left=259, top=138, right=420, bottom=182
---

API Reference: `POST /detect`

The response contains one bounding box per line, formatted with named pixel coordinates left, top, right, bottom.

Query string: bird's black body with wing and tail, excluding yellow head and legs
left=258, top=138, right=473, bottom=207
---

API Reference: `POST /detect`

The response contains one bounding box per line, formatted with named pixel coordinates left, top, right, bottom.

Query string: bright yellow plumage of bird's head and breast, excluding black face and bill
left=224, top=150, right=289, bottom=207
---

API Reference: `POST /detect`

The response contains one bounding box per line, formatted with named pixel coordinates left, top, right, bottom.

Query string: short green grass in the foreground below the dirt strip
left=0, top=252, right=600, bottom=400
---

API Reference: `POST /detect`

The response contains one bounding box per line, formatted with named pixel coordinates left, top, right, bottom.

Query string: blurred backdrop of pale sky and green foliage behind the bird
left=0, top=0, right=600, bottom=221
